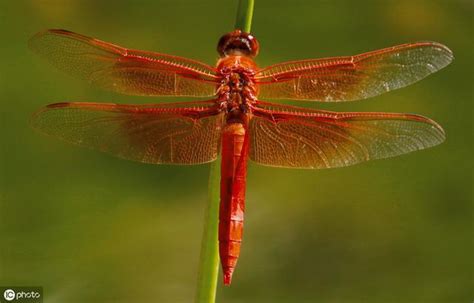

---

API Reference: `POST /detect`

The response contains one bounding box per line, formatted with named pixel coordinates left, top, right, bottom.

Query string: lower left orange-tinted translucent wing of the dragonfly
left=32, top=101, right=223, bottom=164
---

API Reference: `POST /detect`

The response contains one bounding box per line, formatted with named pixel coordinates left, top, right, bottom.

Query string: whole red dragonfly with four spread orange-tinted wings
left=30, top=30, right=453, bottom=285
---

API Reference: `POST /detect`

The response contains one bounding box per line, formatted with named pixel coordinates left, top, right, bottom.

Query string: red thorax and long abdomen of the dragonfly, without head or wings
left=217, top=55, right=257, bottom=285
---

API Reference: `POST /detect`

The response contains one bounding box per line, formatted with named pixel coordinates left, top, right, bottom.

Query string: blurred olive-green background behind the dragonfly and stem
left=0, top=0, right=474, bottom=303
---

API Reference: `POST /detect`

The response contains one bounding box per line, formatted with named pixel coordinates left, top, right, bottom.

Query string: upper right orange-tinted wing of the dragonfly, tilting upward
left=256, top=42, right=453, bottom=102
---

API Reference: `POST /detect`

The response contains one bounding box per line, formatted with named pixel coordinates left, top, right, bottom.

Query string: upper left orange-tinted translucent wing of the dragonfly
left=29, top=30, right=219, bottom=97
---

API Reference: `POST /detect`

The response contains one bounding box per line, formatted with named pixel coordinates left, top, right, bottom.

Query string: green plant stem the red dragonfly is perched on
left=195, top=0, right=254, bottom=303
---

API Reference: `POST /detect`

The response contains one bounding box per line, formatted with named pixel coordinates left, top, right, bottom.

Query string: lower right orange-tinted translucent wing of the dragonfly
left=249, top=102, right=445, bottom=168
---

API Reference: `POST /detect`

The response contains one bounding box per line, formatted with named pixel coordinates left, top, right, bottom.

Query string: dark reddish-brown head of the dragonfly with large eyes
left=217, top=29, right=259, bottom=58
